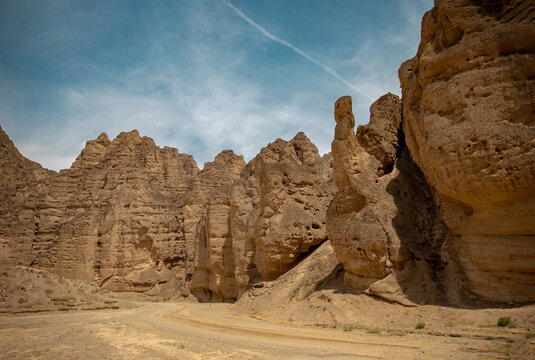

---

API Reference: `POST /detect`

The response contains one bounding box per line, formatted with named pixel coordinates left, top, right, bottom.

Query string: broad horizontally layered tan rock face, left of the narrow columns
left=32, top=130, right=198, bottom=294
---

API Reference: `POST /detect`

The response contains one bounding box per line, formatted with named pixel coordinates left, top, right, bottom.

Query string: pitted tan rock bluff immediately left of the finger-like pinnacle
left=249, top=133, right=334, bottom=279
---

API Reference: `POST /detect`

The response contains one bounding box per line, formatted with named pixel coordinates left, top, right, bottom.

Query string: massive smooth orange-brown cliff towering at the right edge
left=399, top=0, right=535, bottom=302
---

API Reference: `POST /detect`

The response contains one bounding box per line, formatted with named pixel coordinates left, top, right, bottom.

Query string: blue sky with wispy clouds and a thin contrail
left=0, top=0, right=433, bottom=170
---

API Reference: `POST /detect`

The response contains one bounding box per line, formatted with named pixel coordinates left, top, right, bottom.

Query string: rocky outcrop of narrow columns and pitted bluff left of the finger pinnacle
left=191, top=133, right=334, bottom=300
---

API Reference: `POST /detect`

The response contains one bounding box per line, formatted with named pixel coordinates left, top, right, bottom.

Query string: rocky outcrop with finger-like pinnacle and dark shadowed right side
left=327, top=94, right=449, bottom=304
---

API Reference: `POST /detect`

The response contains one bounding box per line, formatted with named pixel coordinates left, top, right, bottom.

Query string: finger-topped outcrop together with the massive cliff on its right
left=327, top=0, right=535, bottom=304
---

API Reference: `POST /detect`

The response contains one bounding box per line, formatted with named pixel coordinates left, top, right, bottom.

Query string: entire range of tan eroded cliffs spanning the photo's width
left=0, top=0, right=535, bottom=307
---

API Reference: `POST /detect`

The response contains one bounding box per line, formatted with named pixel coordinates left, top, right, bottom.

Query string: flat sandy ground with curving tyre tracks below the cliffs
left=0, top=301, right=535, bottom=359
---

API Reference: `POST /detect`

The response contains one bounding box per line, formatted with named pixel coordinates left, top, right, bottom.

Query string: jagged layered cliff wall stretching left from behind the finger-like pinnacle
left=0, top=125, right=334, bottom=300
